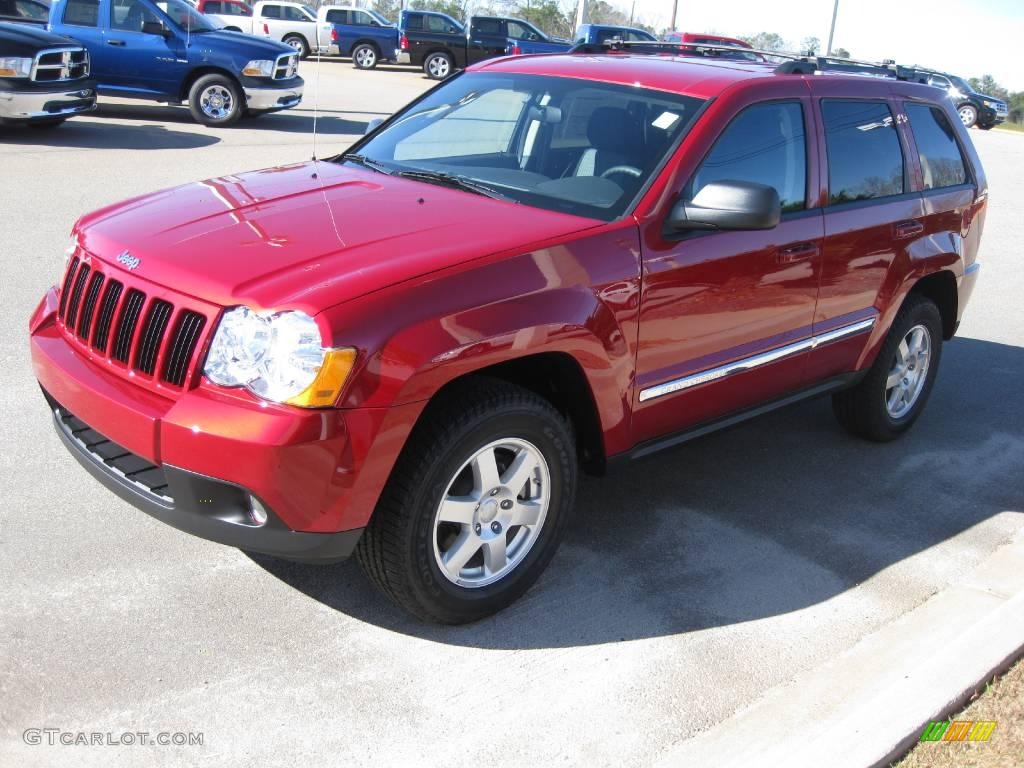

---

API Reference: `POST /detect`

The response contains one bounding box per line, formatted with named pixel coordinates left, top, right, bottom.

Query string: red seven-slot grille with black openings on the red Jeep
left=57, top=257, right=214, bottom=387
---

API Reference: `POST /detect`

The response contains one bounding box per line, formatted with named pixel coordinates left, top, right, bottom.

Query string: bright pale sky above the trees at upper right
left=611, top=0, right=1024, bottom=91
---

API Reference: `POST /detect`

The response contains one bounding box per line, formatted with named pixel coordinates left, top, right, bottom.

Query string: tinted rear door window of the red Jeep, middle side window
left=821, top=99, right=904, bottom=205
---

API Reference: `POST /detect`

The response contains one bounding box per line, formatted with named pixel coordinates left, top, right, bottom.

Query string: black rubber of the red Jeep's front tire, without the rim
left=356, top=377, right=578, bottom=624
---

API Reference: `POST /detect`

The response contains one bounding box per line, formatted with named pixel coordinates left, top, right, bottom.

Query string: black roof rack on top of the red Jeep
left=568, top=38, right=928, bottom=83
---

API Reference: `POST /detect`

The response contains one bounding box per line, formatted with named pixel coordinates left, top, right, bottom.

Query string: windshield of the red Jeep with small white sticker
left=335, top=73, right=702, bottom=221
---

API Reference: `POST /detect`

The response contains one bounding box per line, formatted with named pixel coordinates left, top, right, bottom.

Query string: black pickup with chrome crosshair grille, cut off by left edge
left=0, top=22, right=96, bottom=128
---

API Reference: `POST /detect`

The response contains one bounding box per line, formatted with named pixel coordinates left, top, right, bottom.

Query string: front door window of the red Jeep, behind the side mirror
left=686, top=101, right=807, bottom=212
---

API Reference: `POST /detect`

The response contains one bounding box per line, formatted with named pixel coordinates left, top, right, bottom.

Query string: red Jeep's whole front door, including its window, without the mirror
left=633, top=97, right=823, bottom=442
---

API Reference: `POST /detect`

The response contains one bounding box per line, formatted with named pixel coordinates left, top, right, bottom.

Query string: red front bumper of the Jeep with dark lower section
left=30, top=289, right=423, bottom=562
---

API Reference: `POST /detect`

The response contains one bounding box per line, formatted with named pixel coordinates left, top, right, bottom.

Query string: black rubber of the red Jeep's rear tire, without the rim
left=833, top=294, right=942, bottom=442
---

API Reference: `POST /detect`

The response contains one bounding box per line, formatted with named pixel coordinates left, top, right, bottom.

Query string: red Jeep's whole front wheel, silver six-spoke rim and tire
left=356, top=377, right=577, bottom=624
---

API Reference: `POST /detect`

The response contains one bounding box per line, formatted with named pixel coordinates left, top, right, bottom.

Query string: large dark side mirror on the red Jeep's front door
left=666, top=180, right=782, bottom=232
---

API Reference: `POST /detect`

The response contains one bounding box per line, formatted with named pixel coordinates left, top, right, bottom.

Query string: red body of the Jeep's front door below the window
left=634, top=217, right=822, bottom=442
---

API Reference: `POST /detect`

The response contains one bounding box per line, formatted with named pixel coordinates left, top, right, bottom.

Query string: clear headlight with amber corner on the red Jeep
left=203, top=306, right=355, bottom=408
